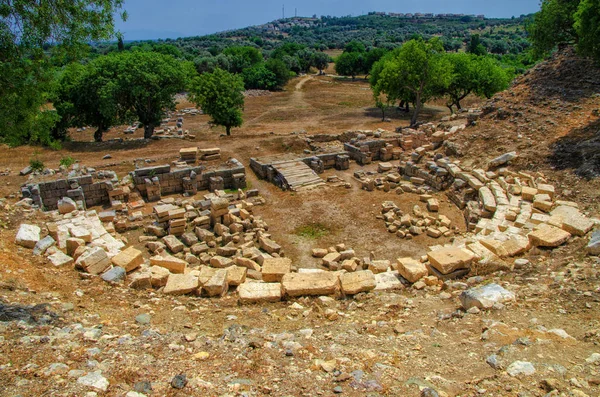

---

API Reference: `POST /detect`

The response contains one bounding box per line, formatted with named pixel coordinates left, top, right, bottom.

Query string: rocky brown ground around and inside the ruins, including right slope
left=0, top=47, right=600, bottom=397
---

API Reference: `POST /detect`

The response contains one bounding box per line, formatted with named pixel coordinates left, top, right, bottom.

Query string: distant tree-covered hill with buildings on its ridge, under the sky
left=97, top=13, right=529, bottom=59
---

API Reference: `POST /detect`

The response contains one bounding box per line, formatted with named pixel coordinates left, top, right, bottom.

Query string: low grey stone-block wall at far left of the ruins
left=21, top=175, right=113, bottom=211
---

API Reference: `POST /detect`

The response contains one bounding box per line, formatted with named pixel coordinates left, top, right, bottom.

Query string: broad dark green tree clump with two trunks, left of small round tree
left=53, top=51, right=190, bottom=142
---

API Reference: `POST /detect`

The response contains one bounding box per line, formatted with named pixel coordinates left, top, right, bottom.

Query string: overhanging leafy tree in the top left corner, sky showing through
left=0, top=0, right=126, bottom=145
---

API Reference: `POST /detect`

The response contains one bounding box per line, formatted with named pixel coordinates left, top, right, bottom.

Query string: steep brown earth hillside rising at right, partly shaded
left=454, top=48, right=600, bottom=206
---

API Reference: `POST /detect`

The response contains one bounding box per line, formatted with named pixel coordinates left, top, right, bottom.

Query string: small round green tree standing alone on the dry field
left=190, top=68, right=244, bottom=136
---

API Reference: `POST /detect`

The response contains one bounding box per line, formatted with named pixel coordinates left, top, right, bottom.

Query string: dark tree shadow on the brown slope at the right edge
left=549, top=119, right=600, bottom=179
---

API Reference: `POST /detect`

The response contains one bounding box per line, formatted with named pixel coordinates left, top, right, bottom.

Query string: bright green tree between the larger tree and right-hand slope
left=445, top=53, right=512, bottom=112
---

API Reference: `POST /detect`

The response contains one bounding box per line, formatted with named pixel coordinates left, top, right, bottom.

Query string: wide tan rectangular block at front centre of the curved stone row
left=280, top=267, right=339, bottom=297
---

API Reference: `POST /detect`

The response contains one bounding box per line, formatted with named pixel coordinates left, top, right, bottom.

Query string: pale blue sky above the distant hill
left=117, top=0, right=539, bottom=40
